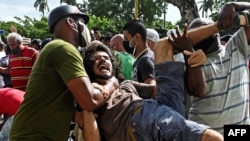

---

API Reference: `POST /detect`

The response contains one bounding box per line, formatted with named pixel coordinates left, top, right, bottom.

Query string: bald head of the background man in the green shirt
left=110, top=34, right=126, bottom=52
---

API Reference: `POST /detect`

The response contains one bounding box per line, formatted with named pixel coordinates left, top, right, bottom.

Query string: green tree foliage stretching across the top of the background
left=0, top=0, right=234, bottom=39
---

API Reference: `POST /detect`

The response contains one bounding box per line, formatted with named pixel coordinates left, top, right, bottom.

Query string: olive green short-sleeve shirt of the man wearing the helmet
left=10, top=39, right=87, bottom=141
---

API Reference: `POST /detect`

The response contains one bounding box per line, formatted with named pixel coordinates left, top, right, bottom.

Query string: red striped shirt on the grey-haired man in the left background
left=9, top=46, right=38, bottom=91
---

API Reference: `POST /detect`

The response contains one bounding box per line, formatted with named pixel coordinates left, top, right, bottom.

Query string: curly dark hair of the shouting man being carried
left=82, top=41, right=125, bottom=82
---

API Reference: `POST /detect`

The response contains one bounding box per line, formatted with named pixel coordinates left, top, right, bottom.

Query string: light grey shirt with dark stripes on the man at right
left=189, top=28, right=250, bottom=134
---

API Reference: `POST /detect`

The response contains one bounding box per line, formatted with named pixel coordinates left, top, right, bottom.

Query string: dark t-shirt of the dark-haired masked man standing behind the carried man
left=131, top=49, right=155, bottom=82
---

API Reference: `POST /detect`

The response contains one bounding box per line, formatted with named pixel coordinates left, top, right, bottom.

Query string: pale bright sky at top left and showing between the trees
left=0, top=0, right=184, bottom=23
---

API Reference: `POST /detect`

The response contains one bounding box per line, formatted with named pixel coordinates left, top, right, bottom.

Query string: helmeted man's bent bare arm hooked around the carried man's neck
left=67, top=77, right=118, bottom=111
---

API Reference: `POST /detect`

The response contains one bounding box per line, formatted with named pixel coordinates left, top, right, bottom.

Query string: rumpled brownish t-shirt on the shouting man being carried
left=96, top=80, right=153, bottom=141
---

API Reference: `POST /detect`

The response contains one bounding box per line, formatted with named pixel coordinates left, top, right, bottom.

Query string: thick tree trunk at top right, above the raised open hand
left=167, top=0, right=200, bottom=24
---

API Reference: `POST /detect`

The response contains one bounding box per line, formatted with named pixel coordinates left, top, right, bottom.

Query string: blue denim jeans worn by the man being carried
left=130, top=62, right=208, bottom=141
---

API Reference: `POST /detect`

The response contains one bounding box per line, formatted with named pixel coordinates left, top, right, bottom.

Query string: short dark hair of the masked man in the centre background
left=122, top=20, right=147, bottom=42
